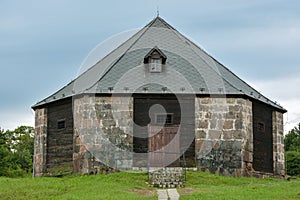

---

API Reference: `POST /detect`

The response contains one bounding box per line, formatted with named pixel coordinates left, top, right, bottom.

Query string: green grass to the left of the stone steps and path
left=0, top=172, right=157, bottom=200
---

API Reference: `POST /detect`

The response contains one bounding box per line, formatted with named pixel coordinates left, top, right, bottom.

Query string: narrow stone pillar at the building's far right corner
left=272, top=111, right=285, bottom=176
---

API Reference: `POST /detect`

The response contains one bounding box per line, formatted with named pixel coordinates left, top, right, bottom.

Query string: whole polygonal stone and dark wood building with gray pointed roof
left=32, top=17, right=286, bottom=176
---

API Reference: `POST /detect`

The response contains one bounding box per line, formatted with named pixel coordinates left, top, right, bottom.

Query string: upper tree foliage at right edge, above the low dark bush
left=284, top=123, right=300, bottom=152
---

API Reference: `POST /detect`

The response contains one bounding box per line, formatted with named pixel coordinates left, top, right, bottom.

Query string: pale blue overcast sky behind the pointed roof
left=0, top=0, right=300, bottom=131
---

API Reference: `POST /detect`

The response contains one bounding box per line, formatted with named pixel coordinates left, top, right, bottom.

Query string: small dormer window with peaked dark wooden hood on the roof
left=144, top=47, right=167, bottom=73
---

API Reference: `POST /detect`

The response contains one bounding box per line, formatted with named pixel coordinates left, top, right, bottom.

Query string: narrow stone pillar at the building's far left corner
left=33, top=108, right=47, bottom=176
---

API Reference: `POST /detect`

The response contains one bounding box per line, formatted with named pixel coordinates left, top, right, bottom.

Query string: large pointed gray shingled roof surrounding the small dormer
left=33, top=17, right=286, bottom=112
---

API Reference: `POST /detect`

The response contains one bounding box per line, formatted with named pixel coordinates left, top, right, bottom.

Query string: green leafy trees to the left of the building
left=0, top=126, right=34, bottom=177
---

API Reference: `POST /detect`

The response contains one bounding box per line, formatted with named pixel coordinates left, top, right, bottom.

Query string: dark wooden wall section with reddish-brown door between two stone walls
left=133, top=95, right=195, bottom=167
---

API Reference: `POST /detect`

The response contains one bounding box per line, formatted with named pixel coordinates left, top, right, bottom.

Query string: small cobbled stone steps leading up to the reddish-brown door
left=149, top=168, right=185, bottom=188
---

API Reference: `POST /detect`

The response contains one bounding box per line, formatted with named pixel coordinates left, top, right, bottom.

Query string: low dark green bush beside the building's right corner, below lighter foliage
left=285, top=151, right=300, bottom=176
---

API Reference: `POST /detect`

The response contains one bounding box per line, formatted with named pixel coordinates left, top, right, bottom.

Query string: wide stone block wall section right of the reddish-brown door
left=195, top=97, right=253, bottom=176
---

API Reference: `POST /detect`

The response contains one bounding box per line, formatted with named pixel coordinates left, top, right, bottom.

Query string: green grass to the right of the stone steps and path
left=179, top=172, right=300, bottom=200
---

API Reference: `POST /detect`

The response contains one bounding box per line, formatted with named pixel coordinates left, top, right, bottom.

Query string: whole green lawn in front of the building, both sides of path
left=0, top=172, right=300, bottom=200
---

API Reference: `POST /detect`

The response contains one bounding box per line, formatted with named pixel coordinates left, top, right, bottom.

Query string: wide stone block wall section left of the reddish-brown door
left=73, top=95, right=133, bottom=173
